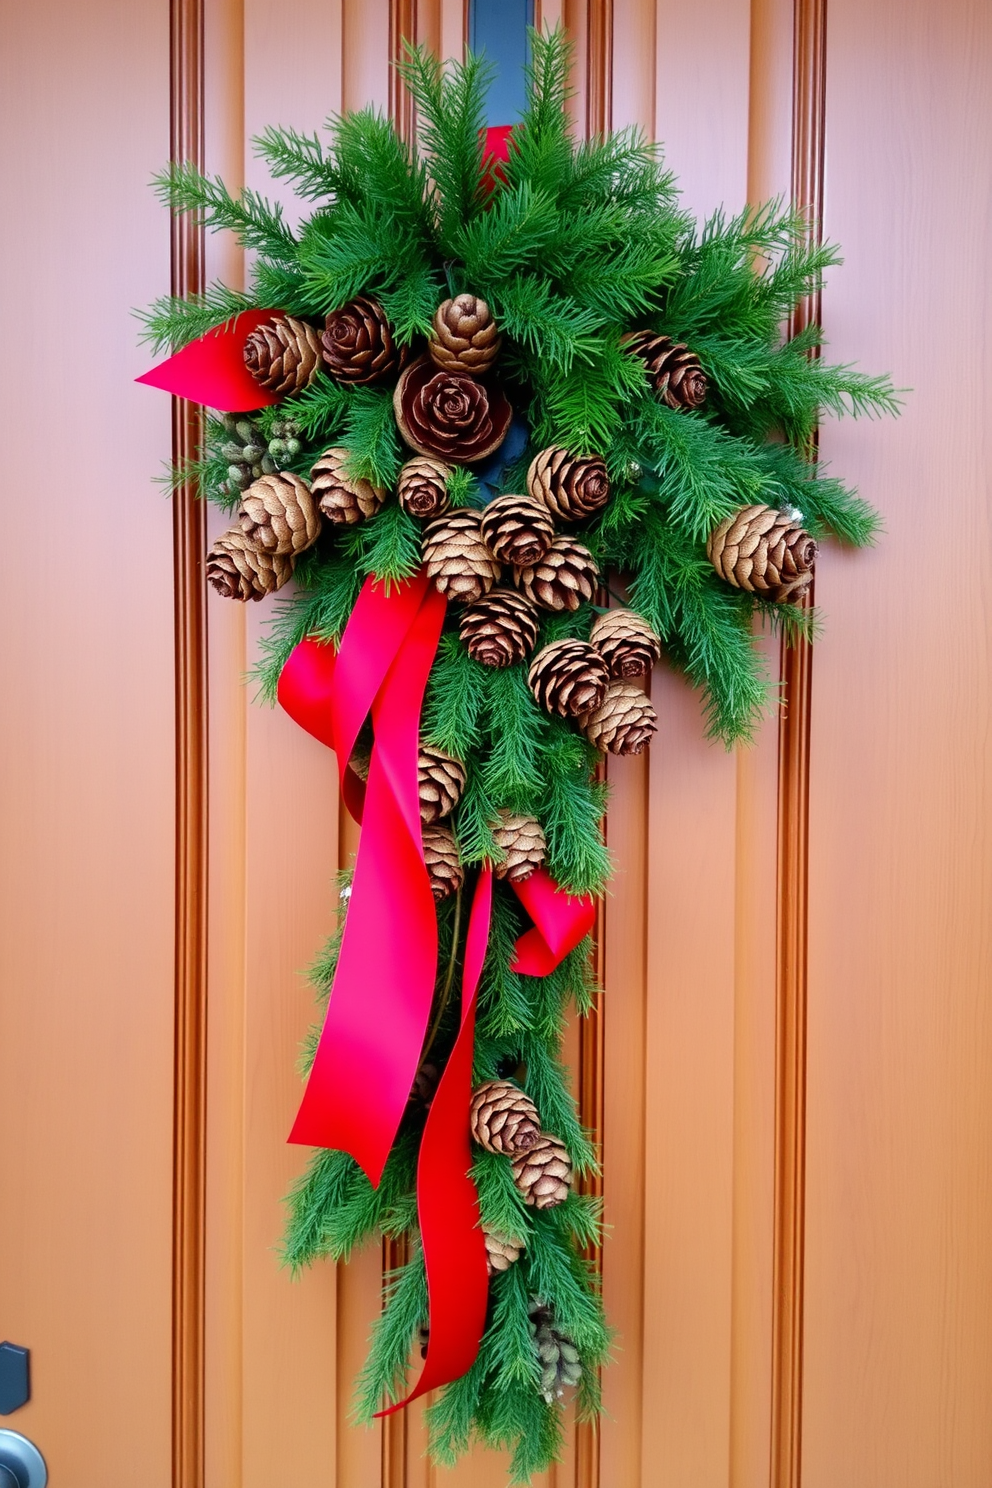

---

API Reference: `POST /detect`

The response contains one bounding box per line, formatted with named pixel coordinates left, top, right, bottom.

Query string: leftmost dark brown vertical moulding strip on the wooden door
left=170, top=0, right=207, bottom=1488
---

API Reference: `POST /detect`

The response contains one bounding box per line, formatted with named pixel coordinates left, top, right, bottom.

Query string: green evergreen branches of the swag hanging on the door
left=144, top=30, right=897, bottom=1482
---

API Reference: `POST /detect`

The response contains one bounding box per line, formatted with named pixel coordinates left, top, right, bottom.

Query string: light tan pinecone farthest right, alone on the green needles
left=706, top=506, right=817, bottom=604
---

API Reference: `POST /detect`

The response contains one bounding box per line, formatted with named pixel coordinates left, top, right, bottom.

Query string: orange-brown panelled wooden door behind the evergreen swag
left=0, top=0, right=992, bottom=1488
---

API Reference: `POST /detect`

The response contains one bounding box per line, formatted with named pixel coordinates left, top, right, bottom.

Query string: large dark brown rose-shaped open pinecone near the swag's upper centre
left=393, top=357, right=513, bottom=464
